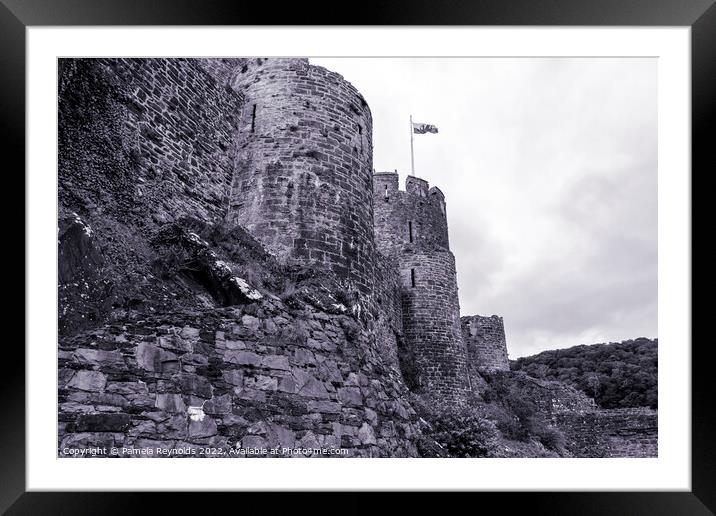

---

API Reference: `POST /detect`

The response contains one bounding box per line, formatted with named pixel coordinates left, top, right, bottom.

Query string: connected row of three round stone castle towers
left=202, top=59, right=509, bottom=400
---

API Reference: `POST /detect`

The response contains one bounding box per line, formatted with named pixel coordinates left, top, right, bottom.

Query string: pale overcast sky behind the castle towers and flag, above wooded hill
left=311, top=58, right=657, bottom=358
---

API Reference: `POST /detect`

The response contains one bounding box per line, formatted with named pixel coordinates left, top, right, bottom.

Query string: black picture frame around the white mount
left=0, top=0, right=716, bottom=515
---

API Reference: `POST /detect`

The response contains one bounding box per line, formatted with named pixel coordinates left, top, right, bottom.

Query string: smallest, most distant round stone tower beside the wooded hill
left=460, top=315, right=510, bottom=374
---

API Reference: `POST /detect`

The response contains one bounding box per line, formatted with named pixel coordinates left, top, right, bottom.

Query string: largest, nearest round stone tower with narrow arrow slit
left=203, top=59, right=374, bottom=293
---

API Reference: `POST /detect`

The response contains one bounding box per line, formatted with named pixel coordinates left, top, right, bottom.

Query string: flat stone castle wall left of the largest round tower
left=58, top=58, right=243, bottom=223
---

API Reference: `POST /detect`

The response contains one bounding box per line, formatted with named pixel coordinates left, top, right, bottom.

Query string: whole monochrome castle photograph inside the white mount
left=58, top=55, right=656, bottom=464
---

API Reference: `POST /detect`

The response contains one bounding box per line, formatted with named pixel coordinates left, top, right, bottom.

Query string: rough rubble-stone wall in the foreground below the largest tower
left=58, top=300, right=420, bottom=458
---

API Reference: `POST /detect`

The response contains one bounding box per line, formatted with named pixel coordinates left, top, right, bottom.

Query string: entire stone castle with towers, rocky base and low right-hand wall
left=58, top=58, right=656, bottom=457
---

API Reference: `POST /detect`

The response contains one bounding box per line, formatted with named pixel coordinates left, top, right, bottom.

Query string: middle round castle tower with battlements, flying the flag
left=374, top=172, right=469, bottom=400
